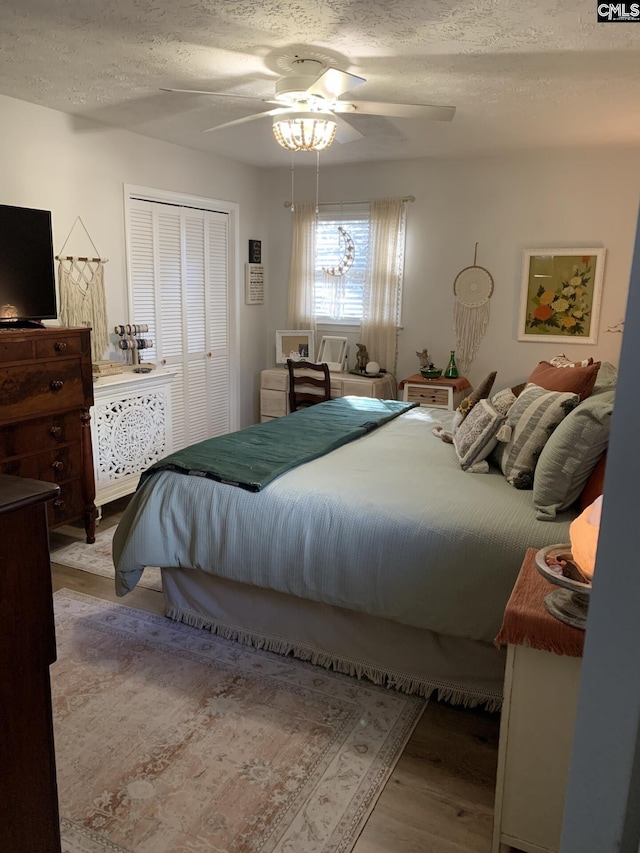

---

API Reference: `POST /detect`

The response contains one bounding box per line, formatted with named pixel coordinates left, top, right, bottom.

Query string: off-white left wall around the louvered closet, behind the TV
left=0, top=96, right=267, bottom=426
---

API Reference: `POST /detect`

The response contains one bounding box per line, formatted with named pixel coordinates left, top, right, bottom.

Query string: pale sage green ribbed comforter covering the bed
left=113, top=409, right=574, bottom=642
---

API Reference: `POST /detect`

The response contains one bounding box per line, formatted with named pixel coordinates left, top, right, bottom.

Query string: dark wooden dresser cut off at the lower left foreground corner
left=0, top=474, right=60, bottom=853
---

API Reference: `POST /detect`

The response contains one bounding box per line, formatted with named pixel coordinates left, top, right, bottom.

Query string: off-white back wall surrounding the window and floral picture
left=267, top=153, right=640, bottom=387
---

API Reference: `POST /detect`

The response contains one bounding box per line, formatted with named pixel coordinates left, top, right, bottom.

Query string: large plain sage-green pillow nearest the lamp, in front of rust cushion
left=533, top=388, right=615, bottom=521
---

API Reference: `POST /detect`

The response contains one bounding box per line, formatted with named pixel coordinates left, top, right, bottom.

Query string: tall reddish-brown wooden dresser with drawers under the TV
left=0, top=327, right=96, bottom=542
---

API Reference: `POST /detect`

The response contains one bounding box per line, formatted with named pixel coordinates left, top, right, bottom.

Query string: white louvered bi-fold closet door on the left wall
left=128, top=198, right=231, bottom=450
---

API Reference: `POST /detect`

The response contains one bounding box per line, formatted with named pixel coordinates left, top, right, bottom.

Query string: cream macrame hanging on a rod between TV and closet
left=56, top=216, right=109, bottom=362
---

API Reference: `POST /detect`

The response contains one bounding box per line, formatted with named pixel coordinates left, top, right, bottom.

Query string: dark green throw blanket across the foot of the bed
left=138, top=397, right=418, bottom=492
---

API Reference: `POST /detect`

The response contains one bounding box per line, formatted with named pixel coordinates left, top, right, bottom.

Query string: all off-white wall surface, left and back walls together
left=0, top=91, right=640, bottom=418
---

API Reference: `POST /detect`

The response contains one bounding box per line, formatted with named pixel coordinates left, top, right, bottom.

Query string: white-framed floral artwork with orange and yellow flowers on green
left=518, top=249, right=606, bottom=344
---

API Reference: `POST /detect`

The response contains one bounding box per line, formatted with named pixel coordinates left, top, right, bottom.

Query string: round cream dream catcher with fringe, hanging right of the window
left=453, top=243, right=493, bottom=373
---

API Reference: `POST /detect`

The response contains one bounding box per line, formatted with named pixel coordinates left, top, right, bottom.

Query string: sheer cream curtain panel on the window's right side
left=360, top=198, right=405, bottom=375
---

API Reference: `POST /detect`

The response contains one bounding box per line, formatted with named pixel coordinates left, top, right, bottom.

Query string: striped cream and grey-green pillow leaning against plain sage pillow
left=494, top=382, right=580, bottom=489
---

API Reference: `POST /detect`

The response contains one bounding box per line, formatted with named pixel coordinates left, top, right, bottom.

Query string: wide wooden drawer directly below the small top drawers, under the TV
left=0, top=358, right=84, bottom=423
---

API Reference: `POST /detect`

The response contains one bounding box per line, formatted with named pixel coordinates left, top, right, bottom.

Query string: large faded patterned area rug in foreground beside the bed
left=51, top=590, right=426, bottom=853
